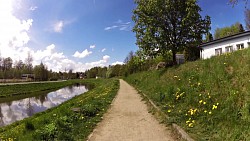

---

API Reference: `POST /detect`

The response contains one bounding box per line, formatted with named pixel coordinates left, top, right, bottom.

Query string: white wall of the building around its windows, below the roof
left=201, top=36, right=250, bottom=59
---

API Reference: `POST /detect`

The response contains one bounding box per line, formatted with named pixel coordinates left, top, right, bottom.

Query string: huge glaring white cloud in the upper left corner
left=0, top=0, right=33, bottom=58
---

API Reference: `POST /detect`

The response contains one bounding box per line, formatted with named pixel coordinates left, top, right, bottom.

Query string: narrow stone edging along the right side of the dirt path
left=131, top=82, right=194, bottom=141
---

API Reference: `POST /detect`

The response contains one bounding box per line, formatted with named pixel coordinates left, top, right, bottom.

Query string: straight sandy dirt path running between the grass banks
left=89, top=80, right=174, bottom=141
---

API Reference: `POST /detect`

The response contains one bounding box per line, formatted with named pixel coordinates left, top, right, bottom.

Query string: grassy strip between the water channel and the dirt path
left=0, top=79, right=119, bottom=141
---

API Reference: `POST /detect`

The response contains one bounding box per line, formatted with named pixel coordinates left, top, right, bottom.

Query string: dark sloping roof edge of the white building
left=200, top=31, right=250, bottom=47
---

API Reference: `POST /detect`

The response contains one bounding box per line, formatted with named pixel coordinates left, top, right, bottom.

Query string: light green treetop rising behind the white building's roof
left=214, top=22, right=244, bottom=39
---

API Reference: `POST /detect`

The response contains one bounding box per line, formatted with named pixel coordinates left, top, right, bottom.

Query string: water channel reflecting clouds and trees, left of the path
left=0, top=85, right=87, bottom=126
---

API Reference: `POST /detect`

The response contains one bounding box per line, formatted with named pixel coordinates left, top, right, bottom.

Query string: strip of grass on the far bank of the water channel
left=0, top=80, right=84, bottom=100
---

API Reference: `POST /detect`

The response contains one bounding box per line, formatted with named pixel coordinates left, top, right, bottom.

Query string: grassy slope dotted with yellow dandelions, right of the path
left=126, top=49, right=250, bottom=140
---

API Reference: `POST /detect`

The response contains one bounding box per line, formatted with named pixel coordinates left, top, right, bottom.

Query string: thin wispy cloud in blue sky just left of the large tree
left=104, top=20, right=132, bottom=31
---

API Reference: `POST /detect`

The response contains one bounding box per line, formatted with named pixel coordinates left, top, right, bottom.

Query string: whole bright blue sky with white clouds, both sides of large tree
left=0, top=0, right=250, bottom=72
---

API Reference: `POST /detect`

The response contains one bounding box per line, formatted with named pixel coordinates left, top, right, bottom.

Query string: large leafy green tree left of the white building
left=133, top=0, right=211, bottom=63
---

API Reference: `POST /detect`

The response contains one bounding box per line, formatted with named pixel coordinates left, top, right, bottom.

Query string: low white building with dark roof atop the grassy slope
left=200, top=31, right=250, bottom=59
